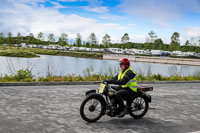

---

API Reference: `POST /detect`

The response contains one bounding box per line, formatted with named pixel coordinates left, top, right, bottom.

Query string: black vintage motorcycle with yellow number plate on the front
left=80, top=82, right=153, bottom=122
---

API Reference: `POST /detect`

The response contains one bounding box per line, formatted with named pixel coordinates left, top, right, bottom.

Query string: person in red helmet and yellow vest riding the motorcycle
left=104, top=58, right=137, bottom=118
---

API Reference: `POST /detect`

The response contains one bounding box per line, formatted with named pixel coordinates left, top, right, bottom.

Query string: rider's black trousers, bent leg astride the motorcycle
left=114, top=87, right=135, bottom=112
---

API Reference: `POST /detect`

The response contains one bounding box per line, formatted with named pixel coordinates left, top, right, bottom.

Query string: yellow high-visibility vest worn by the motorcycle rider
left=118, top=67, right=137, bottom=92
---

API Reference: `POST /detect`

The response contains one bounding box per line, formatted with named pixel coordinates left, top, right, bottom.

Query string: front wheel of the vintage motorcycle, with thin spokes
left=80, top=95, right=106, bottom=122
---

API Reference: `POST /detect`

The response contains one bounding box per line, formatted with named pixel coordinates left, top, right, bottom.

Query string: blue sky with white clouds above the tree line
left=0, top=0, right=200, bottom=45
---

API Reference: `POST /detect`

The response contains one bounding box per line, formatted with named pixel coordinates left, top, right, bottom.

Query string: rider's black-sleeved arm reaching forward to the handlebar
left=109, top=70, right=136, bottom=85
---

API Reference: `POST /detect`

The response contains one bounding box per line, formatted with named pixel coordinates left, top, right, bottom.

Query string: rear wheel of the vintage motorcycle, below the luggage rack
left=128, top=95, right=149, bottom=119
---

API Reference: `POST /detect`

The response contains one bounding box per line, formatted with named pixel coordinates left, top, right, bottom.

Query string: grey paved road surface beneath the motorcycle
left=0, top=83, right=200, bottom=133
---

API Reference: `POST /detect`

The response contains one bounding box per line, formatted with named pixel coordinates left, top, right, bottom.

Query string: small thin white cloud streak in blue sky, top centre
left=81, top=6, right=109, bottom=13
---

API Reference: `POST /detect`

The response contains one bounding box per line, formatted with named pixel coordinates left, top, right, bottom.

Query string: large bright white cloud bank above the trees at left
left=0, top=2, right=128, bottom=41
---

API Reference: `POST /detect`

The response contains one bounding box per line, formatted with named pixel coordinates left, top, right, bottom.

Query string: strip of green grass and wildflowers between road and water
left=0, top=69, right=200, bottom=82
